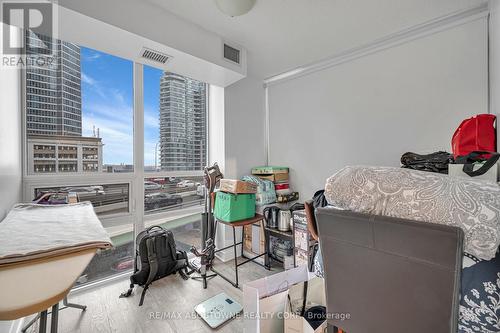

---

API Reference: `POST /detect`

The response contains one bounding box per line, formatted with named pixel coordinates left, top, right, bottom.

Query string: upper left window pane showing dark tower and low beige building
left=26, top=32, right=133, bottom=174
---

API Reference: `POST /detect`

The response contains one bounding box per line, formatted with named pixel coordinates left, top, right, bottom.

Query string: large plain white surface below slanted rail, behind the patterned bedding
left=269, top=18, right=488, bottom=199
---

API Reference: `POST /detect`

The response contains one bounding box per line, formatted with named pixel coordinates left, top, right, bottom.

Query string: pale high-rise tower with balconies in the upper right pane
left=160, top=72, right=207, bottom=171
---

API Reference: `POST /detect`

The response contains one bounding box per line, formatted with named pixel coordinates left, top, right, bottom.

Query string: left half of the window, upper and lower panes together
left=25, top=32, right=135, bottom=284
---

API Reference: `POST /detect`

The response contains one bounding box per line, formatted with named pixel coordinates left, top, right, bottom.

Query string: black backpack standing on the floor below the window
left=120, top=226, right=189, bottom=306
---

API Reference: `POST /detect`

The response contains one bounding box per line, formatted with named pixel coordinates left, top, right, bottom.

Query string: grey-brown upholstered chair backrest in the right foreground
left=316, top=208, right=463, bottom=333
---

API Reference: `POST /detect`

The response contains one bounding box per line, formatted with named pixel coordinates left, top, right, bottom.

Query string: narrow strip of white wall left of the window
left=0, top=24, right=22, bottom=220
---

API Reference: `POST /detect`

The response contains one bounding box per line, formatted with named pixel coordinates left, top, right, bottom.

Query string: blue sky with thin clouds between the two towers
left=80, top=47, right=163, bottom=165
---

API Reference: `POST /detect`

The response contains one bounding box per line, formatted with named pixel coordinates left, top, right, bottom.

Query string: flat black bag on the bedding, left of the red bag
left=401, top=151, right=453, bottom=174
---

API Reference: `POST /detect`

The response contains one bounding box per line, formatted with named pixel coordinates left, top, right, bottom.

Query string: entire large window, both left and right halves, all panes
left=24, top=33, right=208, bottom=284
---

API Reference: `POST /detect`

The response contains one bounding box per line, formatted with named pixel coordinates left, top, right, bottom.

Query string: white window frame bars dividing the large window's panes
left=20, top=42, right=210, bottom=227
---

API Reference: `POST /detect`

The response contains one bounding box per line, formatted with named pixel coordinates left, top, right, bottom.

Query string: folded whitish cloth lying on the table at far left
left=0, top=202, right=112, bottom=266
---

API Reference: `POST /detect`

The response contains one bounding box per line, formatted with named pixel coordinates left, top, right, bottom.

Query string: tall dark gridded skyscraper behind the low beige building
left=26, top=31, right=82, bottom=136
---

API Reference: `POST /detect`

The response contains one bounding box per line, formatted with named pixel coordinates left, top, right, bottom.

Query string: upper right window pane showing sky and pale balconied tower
left=144, top=66, right=207, bottom=172
